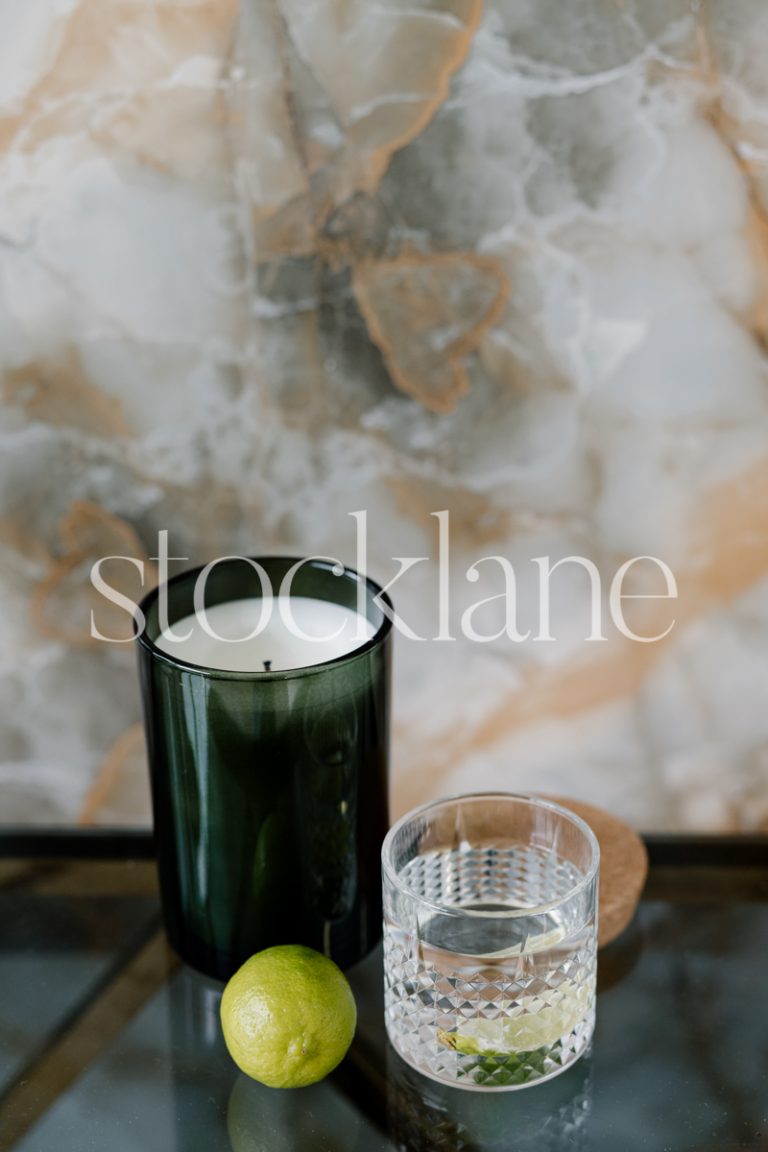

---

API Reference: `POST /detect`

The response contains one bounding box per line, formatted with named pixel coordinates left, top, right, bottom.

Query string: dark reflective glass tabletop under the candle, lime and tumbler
left=0, top=839, right=768, bottom=1152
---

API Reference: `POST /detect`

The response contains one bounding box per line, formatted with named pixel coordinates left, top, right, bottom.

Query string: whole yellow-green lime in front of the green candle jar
left=221, top=945, right=357, bottom=1087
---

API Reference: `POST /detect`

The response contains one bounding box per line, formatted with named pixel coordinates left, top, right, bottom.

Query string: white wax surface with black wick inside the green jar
left=155, top=596, right=374, bottom=672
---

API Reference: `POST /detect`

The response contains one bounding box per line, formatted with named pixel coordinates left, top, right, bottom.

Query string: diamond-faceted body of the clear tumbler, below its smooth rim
left=385, top=846, right=596, bottom=1090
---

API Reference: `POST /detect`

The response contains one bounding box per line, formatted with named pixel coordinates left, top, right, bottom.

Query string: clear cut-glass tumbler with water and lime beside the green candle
left=381, top=793, right=600, bottom=1091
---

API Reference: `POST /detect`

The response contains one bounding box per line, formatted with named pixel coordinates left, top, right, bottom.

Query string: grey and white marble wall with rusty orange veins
left=0, top=0, right=768, bottom=829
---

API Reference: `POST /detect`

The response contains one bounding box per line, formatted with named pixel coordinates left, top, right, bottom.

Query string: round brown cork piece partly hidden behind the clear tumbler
left=545, top=796, right=648, bottom=948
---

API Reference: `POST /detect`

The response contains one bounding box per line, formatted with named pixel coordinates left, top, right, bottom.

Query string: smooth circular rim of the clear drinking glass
left=381, top=791, right=600, bottom=920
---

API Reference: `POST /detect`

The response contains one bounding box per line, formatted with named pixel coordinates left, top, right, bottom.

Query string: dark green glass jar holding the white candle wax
left=137, top=558, right=391, bottom=979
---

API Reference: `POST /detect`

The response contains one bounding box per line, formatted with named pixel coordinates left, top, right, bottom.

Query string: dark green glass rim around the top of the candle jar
left=134, top=555, right=394, bottom=683
